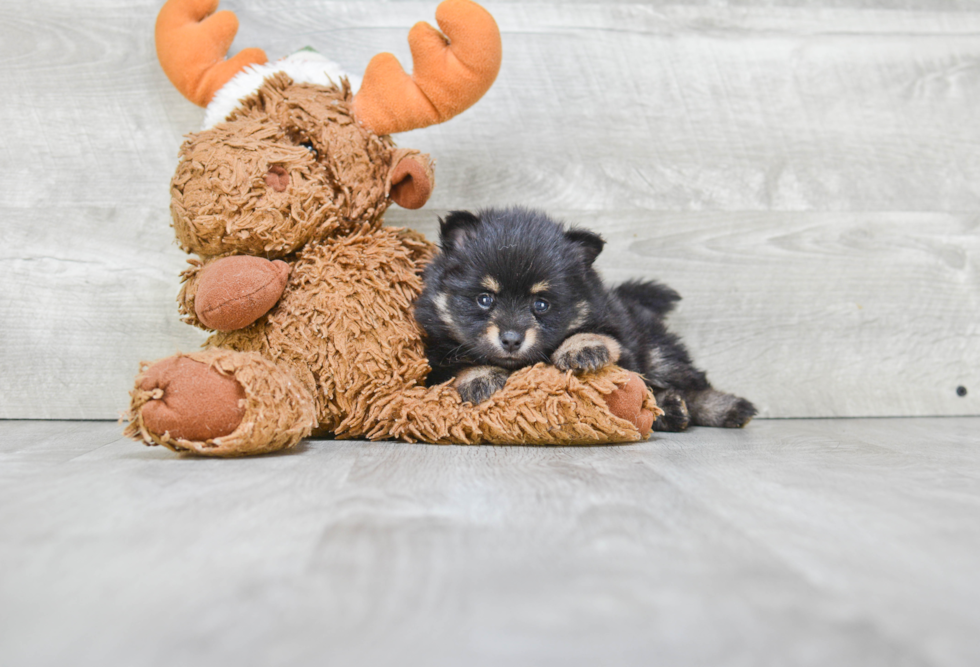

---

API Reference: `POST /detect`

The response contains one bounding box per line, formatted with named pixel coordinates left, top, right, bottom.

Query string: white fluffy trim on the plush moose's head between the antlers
left=201, top=50, right=361, bottom=130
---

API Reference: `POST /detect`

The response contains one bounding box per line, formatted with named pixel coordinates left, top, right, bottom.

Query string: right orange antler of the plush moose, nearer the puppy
left=354, top=0, right=501, bottom=134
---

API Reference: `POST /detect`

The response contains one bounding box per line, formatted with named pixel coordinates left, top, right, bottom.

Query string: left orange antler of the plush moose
left=156, top=0, right=266, bottom=107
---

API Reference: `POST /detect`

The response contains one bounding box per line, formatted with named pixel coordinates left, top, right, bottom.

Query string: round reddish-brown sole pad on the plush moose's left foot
left=140, top=357, right=245, bottom=442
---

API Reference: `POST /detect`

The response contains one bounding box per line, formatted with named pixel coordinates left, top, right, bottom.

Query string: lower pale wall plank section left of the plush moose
left=0, top=207, right=205, bottom=419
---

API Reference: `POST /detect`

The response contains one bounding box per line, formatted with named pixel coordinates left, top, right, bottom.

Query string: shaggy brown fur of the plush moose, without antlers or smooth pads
left=127, top=74, right=660, bottom=456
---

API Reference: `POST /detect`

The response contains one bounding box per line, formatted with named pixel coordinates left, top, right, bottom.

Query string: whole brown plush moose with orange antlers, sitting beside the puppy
left=126, top=0, right=661, bottom=456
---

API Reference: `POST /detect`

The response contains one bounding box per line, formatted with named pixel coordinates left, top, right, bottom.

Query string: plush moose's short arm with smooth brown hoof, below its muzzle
left=177, top=255, right=289, bottom=331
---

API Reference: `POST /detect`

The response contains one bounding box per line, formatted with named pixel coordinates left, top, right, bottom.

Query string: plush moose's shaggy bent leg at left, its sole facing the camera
left=126, top=349, right=316, bottom=456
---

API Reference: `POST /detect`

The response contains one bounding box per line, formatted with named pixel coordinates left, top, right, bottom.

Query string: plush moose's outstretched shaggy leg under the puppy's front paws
left=364, top=364, right=661, bottom=445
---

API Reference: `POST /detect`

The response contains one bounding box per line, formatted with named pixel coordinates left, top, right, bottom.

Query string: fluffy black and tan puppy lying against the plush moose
left=415, top=207, right=756, bottom=431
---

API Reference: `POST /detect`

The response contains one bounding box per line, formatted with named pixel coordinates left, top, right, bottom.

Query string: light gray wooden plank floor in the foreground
left=0, top=418, right=980, bottom=667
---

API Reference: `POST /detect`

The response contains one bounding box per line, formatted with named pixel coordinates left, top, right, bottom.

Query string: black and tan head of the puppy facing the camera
left=433, top=208, right=603, bottom=369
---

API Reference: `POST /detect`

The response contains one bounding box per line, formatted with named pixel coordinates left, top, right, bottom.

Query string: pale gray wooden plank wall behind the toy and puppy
left=0, top=0, right=980, bottom=418
